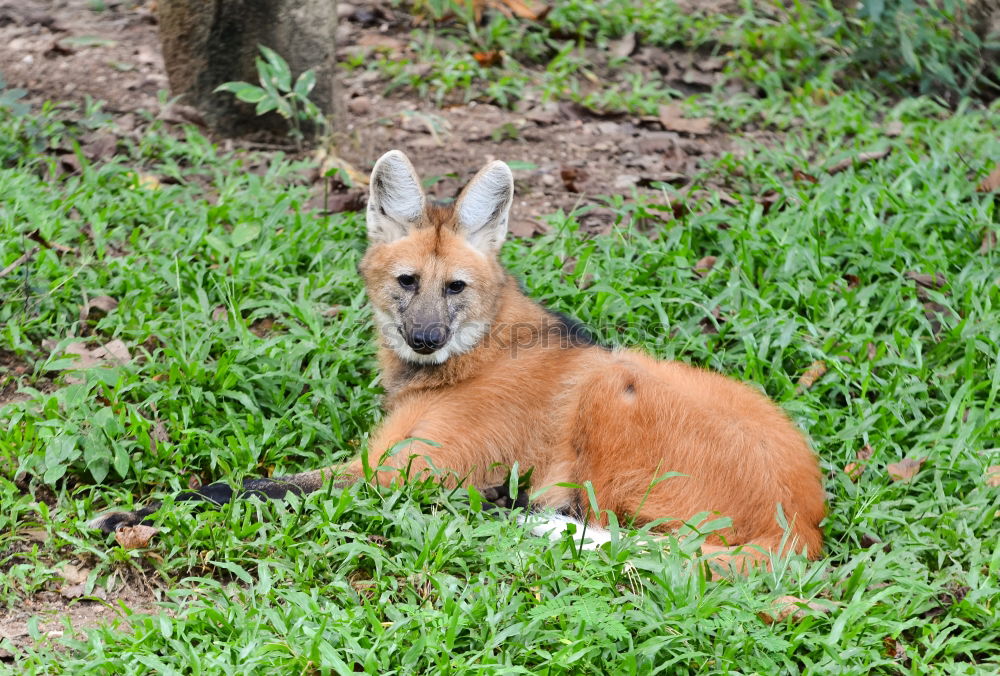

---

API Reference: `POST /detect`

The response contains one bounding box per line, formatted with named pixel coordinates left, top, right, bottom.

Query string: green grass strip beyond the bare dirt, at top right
left=345, top=0, right=1000, bottom=115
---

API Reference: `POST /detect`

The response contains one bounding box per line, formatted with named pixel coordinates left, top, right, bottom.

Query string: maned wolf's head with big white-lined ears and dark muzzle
left=360, top=150, right=514, bottom=364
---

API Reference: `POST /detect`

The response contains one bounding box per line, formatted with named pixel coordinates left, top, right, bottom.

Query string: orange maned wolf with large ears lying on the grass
left=94, top=150, right=824, bottom=568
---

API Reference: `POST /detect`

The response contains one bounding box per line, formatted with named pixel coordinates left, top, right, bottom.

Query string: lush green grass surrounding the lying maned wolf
left=0, top=2, right=1000, bottom=674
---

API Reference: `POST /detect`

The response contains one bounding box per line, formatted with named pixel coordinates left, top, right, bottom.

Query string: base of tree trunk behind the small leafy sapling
left=158, top=0, right=337, bottom=136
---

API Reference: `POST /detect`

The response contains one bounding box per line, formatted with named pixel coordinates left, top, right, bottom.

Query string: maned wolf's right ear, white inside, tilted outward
left=455, top=160, right=514, bottom=255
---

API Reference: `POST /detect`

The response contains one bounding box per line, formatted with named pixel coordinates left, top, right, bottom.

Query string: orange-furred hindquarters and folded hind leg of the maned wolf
left=567, top=355, right=822, bottom=572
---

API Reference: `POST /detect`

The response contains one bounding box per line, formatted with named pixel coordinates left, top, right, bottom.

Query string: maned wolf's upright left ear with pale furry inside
left=367, top=150, right=425, bottom=244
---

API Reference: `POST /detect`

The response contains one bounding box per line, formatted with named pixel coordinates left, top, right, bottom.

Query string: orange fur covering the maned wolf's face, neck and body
left=324, top=152, right=824, bottom=569
